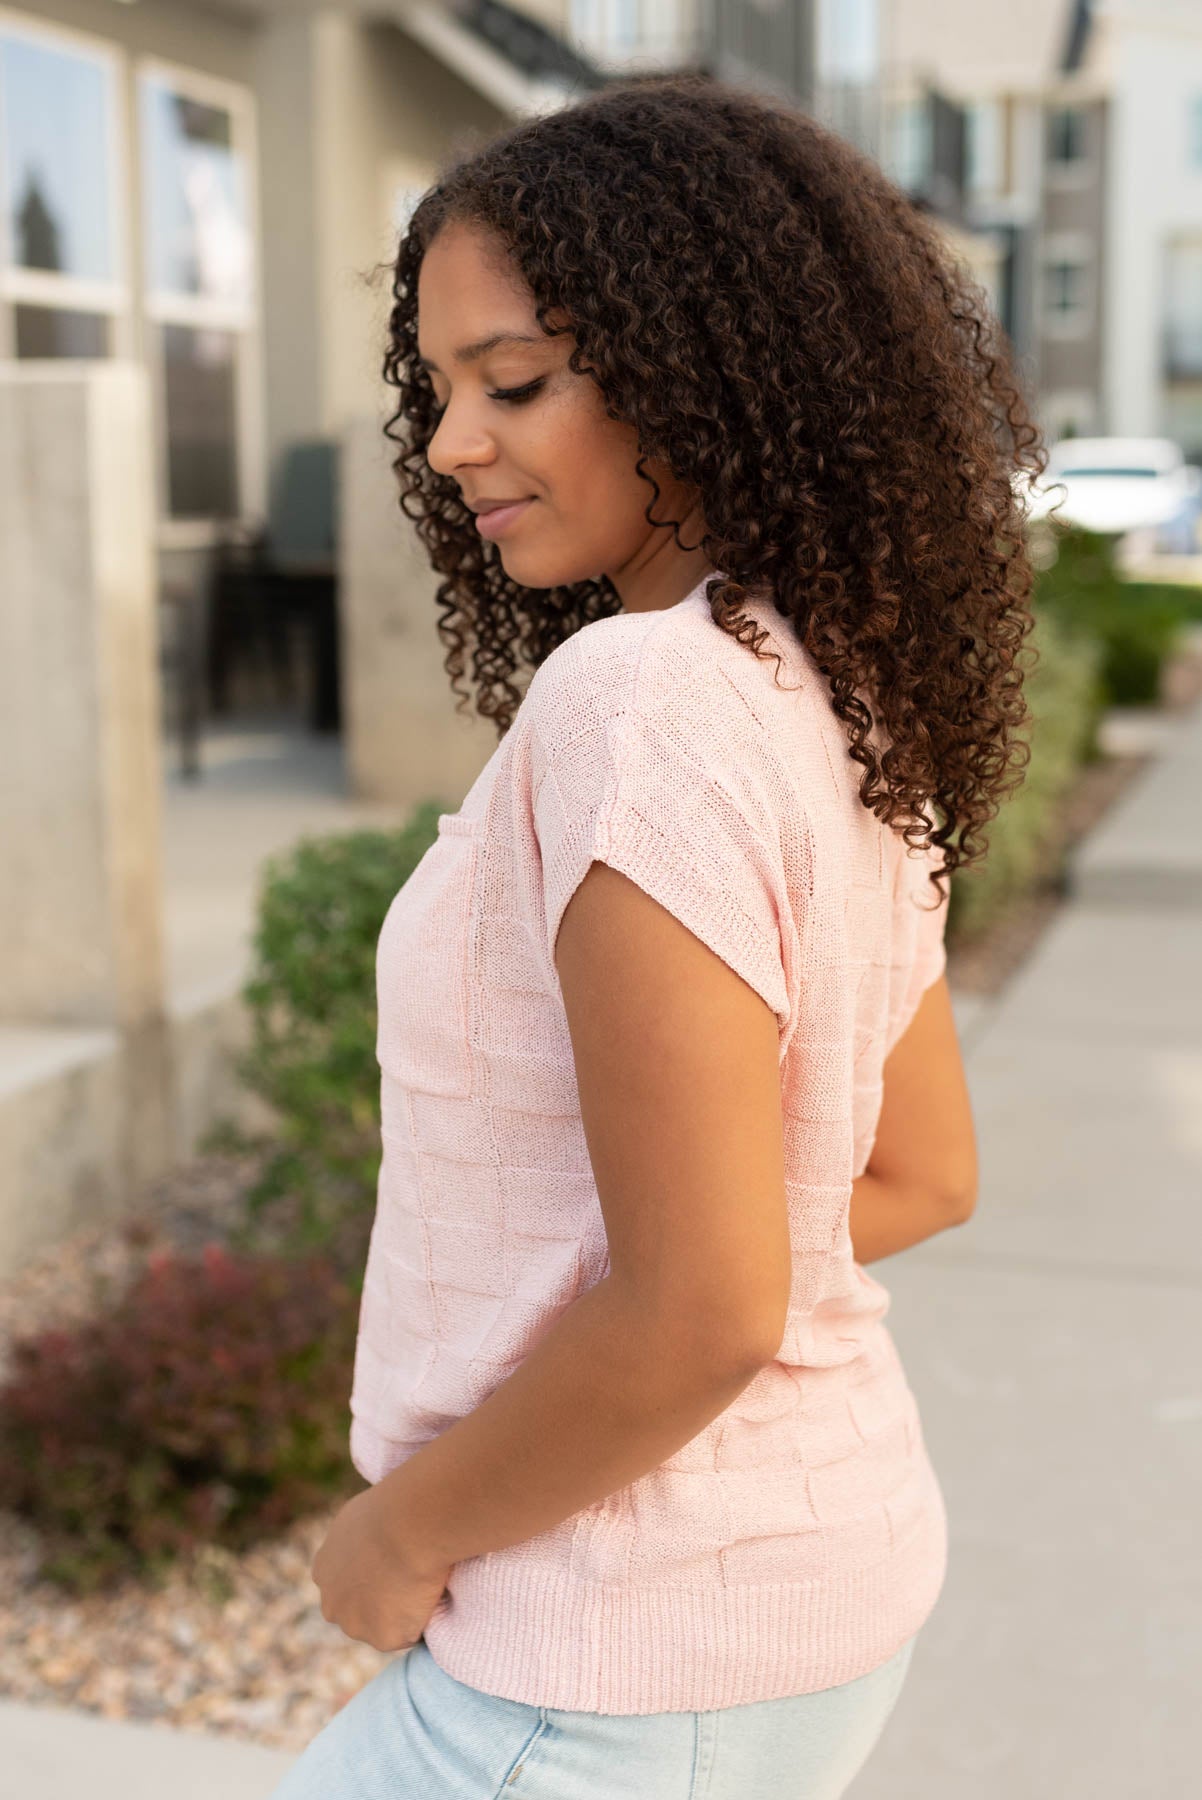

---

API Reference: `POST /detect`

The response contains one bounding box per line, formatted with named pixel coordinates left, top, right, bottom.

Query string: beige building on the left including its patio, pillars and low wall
left=0, top=0, right=615, bottom=1269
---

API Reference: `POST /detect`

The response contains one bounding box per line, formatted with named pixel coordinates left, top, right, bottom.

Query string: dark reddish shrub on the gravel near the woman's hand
left=0, top=1244, right=362, bottom=1593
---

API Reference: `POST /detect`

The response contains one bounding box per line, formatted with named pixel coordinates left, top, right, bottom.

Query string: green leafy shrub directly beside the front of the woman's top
left=207, top=801, right=448, bottom=1280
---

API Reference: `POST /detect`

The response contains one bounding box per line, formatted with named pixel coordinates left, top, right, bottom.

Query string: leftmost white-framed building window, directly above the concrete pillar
left=0, top=18, right=130, bottom=360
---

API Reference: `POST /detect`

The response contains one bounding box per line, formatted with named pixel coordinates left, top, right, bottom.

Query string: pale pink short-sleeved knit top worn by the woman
left=351, top=581, right=946, bottom=1714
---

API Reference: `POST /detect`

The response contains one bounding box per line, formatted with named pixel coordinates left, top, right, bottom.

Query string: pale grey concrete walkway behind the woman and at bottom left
left=0, top=691, right=1202, bottom=1800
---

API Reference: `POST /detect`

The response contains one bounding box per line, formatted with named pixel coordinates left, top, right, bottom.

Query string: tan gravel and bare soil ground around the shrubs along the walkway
left=0, top=637, right=1202, bottom=1750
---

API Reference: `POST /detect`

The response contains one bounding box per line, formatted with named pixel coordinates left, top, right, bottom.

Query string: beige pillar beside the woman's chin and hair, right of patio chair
left=338, top=412, right=498, bottom=812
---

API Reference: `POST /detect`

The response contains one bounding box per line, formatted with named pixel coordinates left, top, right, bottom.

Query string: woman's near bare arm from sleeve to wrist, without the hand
left=378, top=862, right=792, bottom=1570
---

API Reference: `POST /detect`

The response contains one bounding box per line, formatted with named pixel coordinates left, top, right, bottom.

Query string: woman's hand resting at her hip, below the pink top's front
left=309, top=1483, right=453, bottom=1651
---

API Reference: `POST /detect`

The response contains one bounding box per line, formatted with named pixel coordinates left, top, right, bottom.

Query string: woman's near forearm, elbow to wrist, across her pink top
left=378, top=1276, right=761, bottom=1568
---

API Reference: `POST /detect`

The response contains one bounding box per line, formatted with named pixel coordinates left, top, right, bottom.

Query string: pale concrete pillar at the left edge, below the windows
left=0, top=362, right=171, bottom=1183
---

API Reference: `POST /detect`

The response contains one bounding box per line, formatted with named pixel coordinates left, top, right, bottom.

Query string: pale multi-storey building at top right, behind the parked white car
left=887, top=0, right=1202, bottom=459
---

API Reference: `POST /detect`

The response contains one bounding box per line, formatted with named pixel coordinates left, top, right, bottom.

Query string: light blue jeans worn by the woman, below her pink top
left=270, top=1638, right=916, bottom=1800
